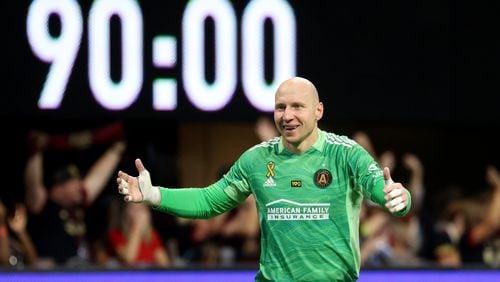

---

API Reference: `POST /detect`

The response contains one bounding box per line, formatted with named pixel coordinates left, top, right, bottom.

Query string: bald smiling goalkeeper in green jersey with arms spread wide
left=117, top=77, right=411, bottom=281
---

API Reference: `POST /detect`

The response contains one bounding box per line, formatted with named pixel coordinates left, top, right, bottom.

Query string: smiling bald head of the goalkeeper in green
left=274, top=81, right=323, bottom=148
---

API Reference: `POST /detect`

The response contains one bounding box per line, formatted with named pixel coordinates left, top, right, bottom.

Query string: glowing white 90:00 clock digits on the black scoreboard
left=26, top=0, right=297, bottom=112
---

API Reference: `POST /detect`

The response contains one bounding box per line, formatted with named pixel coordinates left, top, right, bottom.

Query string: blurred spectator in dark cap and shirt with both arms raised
left=25, top=126, right=125, bottom=267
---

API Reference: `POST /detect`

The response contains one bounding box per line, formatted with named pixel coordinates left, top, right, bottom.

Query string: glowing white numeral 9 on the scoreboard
left=26, top=0, right=83, bottom=109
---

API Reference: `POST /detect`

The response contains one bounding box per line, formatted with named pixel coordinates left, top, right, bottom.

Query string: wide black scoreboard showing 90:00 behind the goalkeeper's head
left=4, top=0, right=500, bottom=125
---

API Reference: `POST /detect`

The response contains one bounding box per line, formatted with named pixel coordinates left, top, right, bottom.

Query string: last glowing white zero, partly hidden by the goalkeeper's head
left=241, top=0, right=296, bottom=111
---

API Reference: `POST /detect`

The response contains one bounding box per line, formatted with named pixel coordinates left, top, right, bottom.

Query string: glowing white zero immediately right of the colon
left=182, top=0, right=237, bottom=111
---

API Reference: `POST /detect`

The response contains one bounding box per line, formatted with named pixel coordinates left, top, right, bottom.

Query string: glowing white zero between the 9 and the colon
left=89, top=0, right=143, bottom=110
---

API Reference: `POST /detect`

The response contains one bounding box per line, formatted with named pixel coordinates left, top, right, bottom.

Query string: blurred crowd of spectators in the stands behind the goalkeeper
left=0, top=117, right=500, bottom=269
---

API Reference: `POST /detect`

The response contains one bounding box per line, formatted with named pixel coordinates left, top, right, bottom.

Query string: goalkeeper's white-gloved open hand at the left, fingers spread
left=116, top=159, right=161, bottom=206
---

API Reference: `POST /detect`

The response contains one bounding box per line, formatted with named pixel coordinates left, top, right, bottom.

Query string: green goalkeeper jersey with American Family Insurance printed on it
left=157, top=130, right=410, bottom=281
